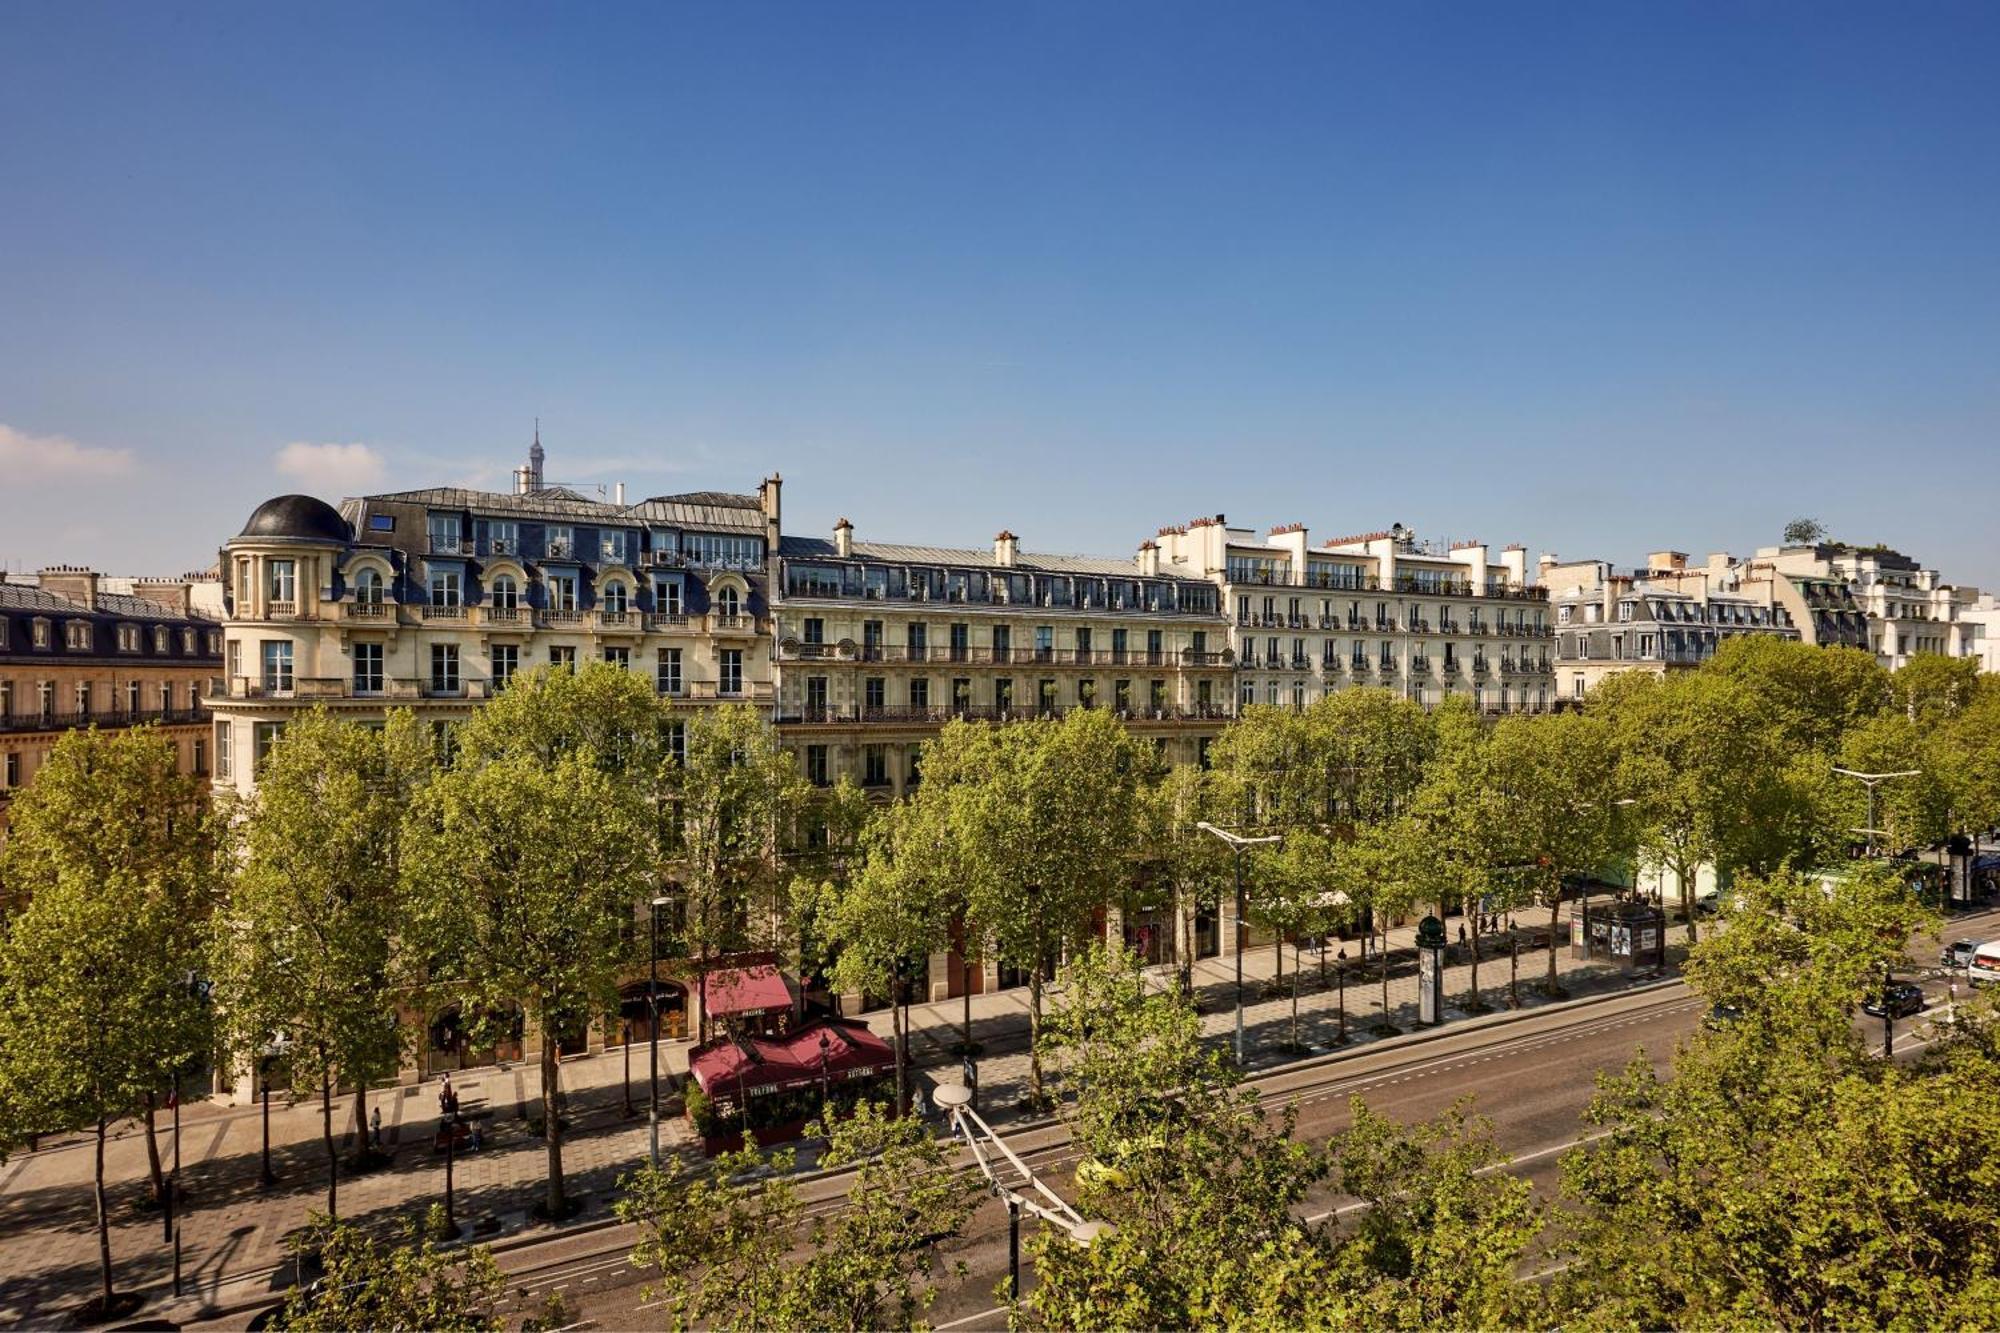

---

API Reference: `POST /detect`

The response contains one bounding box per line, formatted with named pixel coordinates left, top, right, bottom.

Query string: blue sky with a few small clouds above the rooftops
left=0, top=0, right=2000, bottom=584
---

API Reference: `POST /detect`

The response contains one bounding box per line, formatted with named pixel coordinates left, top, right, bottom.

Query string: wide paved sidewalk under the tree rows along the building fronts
left=0, top=904, right=1682, bottom=1323
